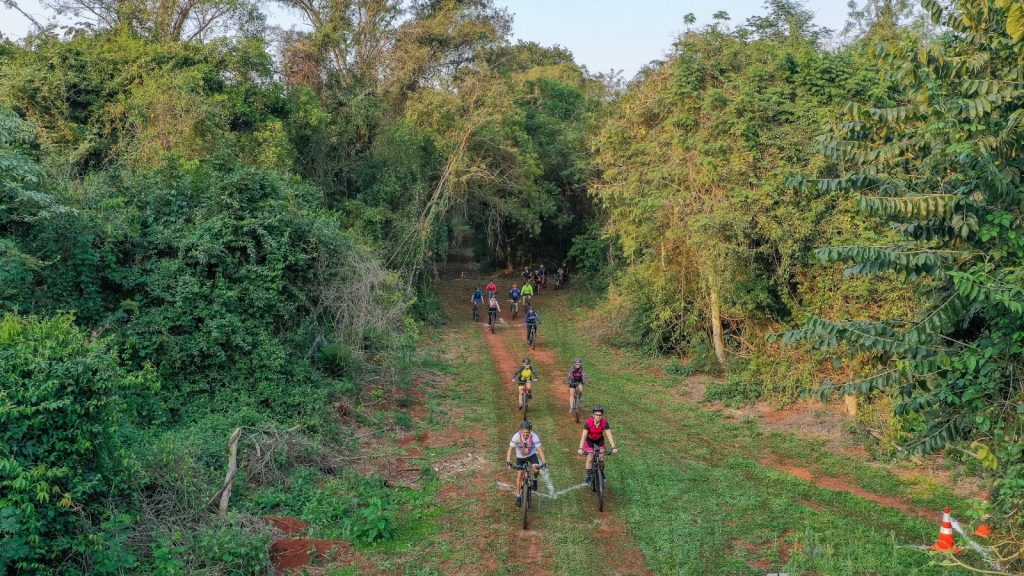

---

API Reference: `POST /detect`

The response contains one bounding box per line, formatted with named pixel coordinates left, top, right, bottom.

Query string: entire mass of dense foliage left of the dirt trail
left=0, top=0, right=604, bottom=574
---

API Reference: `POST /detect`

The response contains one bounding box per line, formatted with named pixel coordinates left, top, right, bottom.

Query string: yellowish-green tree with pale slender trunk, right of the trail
left=592, top=14, right=864, bottom=364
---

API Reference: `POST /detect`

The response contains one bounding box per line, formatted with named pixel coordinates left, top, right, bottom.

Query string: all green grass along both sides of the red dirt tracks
left=272, top=282, right=964, bottom=576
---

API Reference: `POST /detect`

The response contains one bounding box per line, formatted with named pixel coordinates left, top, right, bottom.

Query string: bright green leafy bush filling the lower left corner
left=0, top=315, right=156, bottom=574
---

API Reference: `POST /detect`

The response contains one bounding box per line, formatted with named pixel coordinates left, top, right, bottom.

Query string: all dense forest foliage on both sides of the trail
left=6, top=0, right=1024, bottom=574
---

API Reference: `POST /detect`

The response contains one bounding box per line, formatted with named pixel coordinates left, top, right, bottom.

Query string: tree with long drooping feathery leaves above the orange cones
left=788, top=0, right=1024, bottom=560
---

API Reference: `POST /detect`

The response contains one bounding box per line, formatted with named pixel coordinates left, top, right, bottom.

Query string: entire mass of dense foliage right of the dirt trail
left=589, top=0, right=1024, bottom=562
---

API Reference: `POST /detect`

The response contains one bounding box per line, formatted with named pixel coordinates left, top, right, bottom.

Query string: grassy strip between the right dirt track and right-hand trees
left=542, top=295, right=962, bottom=575
